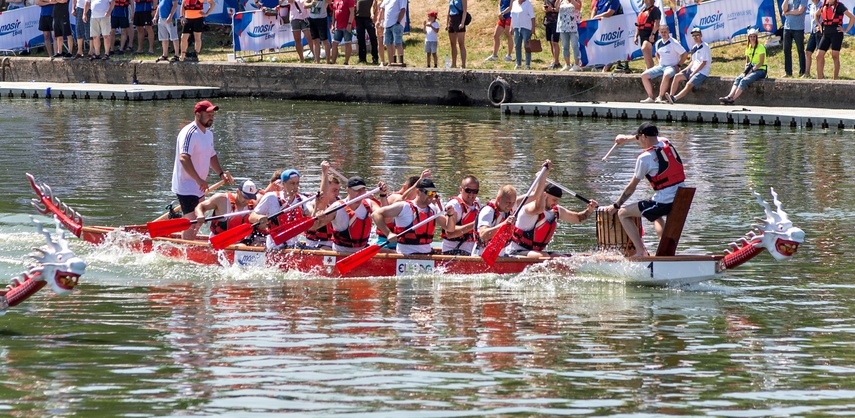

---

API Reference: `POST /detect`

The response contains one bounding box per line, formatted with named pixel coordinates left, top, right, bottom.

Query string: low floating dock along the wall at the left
left=0, top=82, right=220, bottom=101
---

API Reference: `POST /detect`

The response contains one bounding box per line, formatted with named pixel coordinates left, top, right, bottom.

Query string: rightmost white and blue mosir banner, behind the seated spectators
left=677, top=0, right=778, bottom=50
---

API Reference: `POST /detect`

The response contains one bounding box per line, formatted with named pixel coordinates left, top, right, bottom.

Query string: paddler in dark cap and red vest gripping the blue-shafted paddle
left=371, top=178, right=454, bottom=255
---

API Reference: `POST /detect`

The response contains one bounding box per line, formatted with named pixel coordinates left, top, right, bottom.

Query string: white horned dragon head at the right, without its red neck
left=751, top=188, right=805, bottom=260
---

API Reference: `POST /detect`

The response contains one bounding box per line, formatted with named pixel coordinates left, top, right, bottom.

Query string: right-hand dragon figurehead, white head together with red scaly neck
left=722, top=189, right=805, bottom=268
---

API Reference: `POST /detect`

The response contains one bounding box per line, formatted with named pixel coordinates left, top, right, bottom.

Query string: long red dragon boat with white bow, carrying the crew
left=27, top=174, right=804, bottom=286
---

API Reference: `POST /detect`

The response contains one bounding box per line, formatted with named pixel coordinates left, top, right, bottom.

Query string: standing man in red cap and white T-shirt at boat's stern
left=172, top=100, right=235, bottom=239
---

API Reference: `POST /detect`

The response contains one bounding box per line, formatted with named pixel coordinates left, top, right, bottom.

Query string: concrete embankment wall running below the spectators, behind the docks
left=0, top=57, right=855, bottom=108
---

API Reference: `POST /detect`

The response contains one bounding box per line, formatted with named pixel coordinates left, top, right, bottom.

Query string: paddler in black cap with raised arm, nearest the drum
left=505, top=160, right=598, bottom=257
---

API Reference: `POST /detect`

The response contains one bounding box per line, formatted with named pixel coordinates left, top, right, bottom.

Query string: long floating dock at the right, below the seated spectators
left=501, top=102, right=855, bottom=129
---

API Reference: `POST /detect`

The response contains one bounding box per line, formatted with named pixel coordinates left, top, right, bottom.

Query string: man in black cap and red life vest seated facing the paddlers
left=608, top=122, right=686, bottom=257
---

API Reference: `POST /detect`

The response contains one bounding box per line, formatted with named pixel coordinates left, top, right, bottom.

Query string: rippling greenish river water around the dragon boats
left=0, top=98, right=855, bottom=417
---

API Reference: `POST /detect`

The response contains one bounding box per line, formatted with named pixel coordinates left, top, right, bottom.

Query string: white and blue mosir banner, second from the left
left=232, top=10, right=294, bottom=51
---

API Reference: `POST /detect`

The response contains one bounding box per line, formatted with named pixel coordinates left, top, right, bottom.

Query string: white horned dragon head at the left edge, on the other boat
left=29, top=217, right=86, bottom=296
